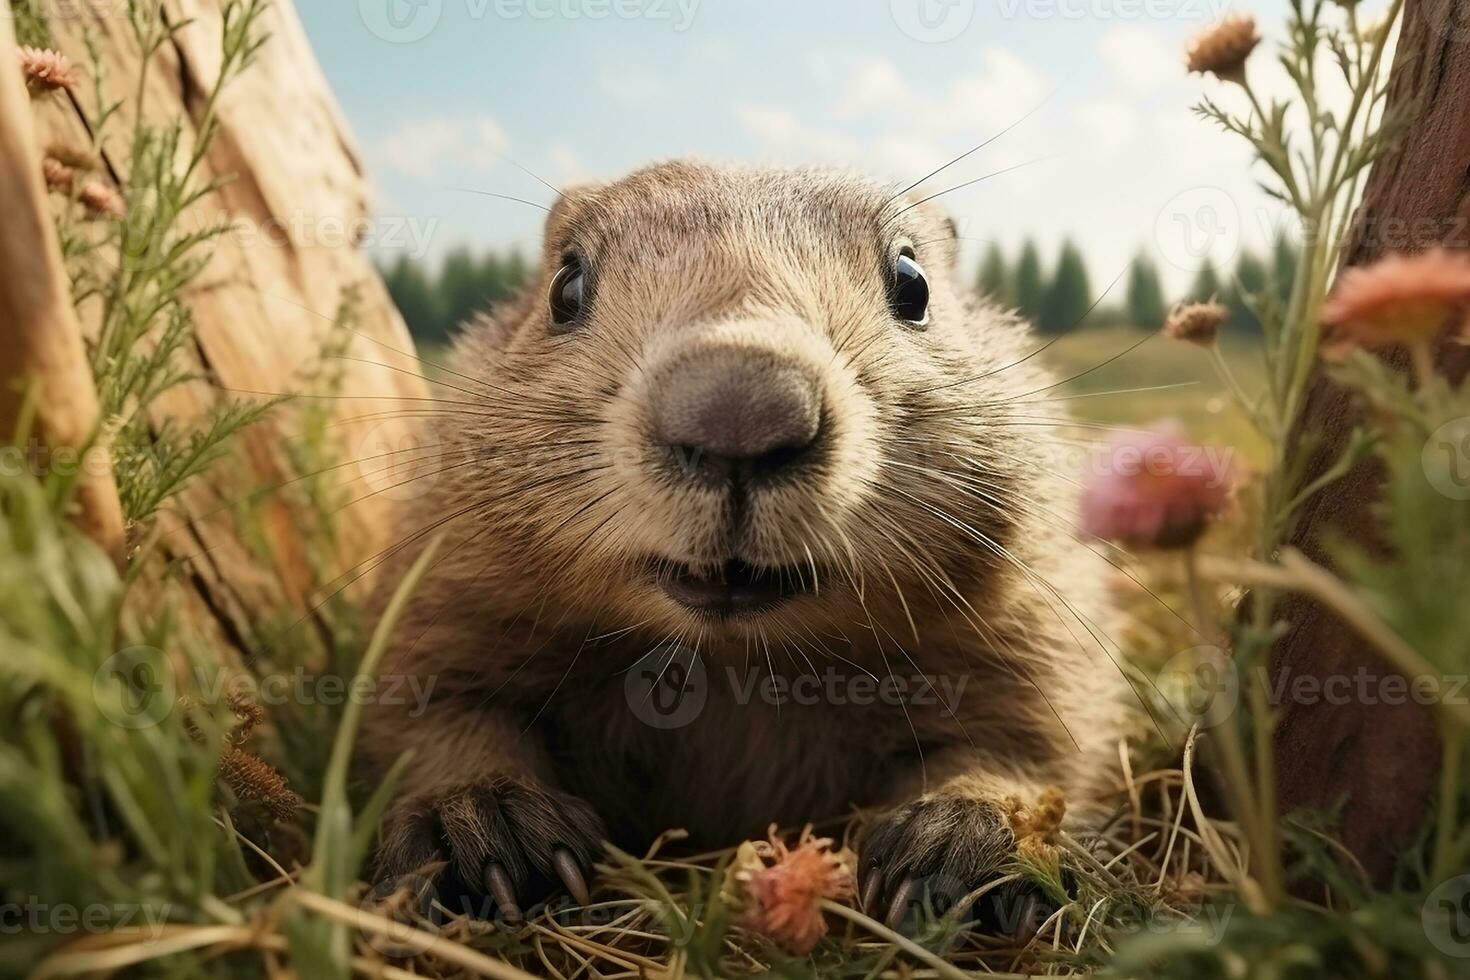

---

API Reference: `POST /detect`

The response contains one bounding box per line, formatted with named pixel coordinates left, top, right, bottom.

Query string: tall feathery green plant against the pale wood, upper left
left=60, top=0, right=275, bottom=523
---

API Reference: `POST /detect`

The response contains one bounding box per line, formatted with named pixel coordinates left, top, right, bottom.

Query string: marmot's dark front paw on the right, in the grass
left=858, top=792, right=1016, bottom=929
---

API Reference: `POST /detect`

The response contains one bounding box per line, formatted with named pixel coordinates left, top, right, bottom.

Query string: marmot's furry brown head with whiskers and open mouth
left=441, top=162, right=1055, bottom=645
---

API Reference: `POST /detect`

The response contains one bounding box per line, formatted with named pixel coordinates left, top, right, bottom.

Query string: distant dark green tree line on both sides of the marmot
left=382, top=238, right=1297, bottom=344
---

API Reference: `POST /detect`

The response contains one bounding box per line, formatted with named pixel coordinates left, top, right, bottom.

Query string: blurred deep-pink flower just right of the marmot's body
left=1082, top=426, right=1232, bottom=548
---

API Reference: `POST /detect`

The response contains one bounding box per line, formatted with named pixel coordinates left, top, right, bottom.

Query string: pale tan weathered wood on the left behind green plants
left=0, top=0, right=434, bottom=652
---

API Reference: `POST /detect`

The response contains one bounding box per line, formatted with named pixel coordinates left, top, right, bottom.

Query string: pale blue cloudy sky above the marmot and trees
left=298, top=0, right=1374, bottom=298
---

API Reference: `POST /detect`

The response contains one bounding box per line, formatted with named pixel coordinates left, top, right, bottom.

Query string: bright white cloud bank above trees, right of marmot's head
left=717, top=39, right=1280, bottom=299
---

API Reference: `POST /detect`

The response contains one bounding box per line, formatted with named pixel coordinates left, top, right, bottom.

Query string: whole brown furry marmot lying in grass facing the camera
left=365, top=162, right=1122, bottom=921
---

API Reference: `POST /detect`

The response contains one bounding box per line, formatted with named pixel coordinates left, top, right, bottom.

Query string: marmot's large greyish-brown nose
left=653, top=348, right=822, bottom=480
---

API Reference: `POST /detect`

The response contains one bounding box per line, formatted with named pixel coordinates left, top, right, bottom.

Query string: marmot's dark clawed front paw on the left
left=373, top=777, right=607, bottom=923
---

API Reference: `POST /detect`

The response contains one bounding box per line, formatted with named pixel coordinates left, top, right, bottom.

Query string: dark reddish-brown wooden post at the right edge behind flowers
left=1272, top=0, right=1470, bottom=880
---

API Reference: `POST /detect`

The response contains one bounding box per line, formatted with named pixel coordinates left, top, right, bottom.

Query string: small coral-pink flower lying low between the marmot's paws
left=731, top=826, right=857, bottom=956
